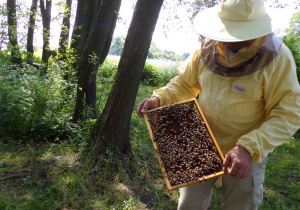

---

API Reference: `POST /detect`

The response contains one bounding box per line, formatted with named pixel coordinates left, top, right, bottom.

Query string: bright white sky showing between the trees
left=0, top=0, right=300, bottom=55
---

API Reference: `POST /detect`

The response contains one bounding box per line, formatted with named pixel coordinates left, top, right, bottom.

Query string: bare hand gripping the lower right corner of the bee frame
left=223, top=146, right=252, bottom=179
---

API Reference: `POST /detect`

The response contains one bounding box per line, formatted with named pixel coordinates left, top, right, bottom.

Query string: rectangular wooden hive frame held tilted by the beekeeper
left=144, top=99, right=225, bottom=193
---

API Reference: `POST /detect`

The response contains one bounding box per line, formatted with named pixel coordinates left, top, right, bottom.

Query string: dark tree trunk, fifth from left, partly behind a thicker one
left=71, top=0, right=97, bottom=54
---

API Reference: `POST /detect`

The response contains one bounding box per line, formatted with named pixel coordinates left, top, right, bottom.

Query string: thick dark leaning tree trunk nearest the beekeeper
left=90, top=0, right=163, bottom=156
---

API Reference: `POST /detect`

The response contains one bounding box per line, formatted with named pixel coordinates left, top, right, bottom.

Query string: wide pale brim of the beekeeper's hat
left=193, top=6, right=291, bottom=42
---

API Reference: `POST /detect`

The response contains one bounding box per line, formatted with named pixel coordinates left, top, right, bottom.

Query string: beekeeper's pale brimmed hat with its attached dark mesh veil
left=194, top=0, right=290, bottom=77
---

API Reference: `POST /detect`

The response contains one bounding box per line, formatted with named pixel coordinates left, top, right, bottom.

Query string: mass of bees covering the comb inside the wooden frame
left=147, top=103, right=222, bottom=186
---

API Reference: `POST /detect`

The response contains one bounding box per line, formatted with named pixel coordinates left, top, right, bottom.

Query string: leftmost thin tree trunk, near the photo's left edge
left=7, top=0, right=22, bottom=64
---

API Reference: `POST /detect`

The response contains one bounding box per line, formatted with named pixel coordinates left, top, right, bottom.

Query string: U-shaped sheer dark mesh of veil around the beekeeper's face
left=201, top=34, right=282, bottom=77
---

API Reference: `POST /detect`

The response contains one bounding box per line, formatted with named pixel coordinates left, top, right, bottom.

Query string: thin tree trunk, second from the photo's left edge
left=27, top=0, right=38, bottom=64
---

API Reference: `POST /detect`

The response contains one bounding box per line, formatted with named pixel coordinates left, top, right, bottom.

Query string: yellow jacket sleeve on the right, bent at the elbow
left=237, top=45, right=300, bottom=163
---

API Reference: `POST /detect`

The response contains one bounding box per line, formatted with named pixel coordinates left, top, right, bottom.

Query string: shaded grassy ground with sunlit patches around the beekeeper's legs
left=0, top=139, right=300, bottom=210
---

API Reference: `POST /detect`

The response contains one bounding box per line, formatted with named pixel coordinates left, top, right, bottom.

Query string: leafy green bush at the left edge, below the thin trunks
left=0, top=63, right=76, bottom=140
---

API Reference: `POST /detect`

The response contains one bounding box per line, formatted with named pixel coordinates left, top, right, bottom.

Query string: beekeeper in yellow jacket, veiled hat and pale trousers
left=137, top=0, right=300, bottom=210
